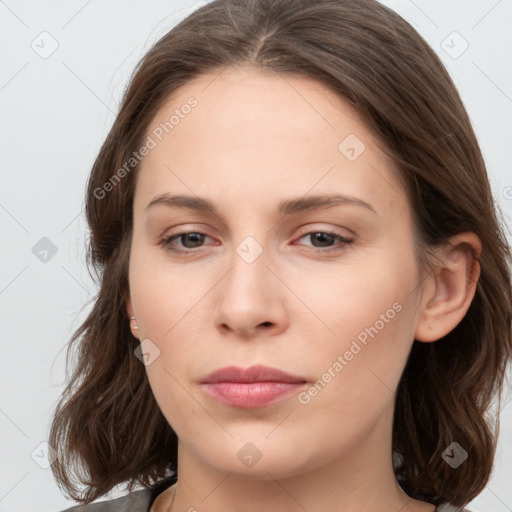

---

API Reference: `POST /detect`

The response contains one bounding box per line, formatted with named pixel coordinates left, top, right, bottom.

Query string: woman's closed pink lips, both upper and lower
left=201, top=365, right=307, bottom=408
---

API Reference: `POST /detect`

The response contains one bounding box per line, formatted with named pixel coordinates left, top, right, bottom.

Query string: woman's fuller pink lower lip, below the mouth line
left=203, top=382, right=307, bottom=408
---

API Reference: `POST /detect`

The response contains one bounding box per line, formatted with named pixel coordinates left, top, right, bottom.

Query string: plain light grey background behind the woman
left=0, top=0, right=512, bottom=512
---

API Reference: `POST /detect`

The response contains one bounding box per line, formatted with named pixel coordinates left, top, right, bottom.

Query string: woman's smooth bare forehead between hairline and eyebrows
left=136, top=67, right=406, bottom=216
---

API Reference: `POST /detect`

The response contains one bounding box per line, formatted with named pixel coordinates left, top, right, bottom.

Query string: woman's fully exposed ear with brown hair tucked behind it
left=415, top=232, right=482, bottom=342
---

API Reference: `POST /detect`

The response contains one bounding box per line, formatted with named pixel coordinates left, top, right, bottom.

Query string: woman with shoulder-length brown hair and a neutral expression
left=50, top=0, right=512, bottom=512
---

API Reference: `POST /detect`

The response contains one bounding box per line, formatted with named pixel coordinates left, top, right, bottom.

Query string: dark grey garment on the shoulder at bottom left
left=62, top=477, right=176, bottom=512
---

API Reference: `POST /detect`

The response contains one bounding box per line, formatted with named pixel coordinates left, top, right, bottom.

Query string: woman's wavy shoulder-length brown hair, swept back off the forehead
left=50, top=0, right=512, bottom=505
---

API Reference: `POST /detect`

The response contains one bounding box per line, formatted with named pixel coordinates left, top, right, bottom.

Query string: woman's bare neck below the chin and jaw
left=169, top=408, right=435, bottom=512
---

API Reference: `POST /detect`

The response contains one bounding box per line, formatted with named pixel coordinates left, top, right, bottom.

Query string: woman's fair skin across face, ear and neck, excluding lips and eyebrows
left=127, top=67, right=481, bottom=512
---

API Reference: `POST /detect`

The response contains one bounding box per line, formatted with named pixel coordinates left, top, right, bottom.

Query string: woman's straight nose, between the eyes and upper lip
left=214, top=243, right=288, bottom=339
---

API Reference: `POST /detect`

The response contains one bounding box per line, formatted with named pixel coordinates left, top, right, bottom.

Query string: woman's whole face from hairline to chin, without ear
left=128, top=67, right=428, bottom=479
